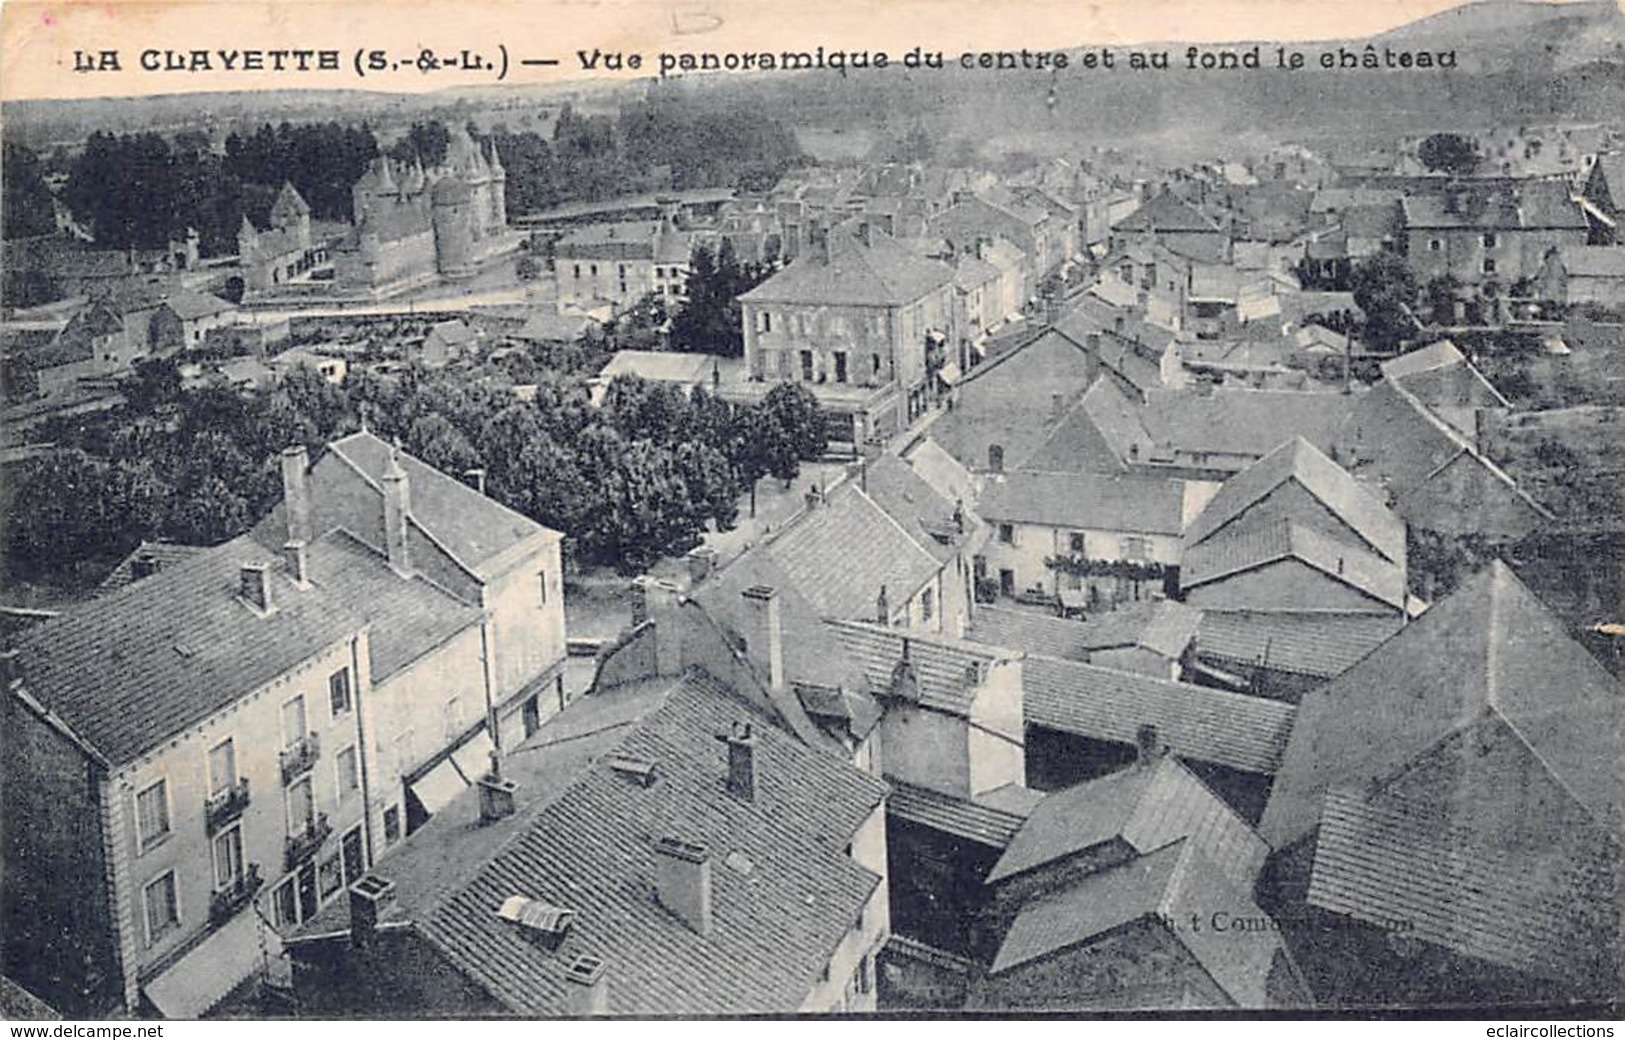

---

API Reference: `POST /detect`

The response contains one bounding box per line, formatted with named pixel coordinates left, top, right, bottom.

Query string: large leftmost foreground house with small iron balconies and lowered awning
left=5, top=536, right=375, bottom=1017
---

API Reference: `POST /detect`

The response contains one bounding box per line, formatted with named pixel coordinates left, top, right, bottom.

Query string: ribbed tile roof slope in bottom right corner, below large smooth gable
left=1308, top=788, right=1619, bottom=995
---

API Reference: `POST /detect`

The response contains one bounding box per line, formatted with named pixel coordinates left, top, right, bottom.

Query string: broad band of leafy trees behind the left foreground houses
left=7, top=361, right=824, bottom=580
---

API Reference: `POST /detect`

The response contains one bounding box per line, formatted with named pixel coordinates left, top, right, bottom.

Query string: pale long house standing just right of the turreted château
left=553, top=216, right=692, bottom=312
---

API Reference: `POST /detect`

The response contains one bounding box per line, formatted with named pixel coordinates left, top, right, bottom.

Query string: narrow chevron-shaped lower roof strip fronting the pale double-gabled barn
left=1180, top=518, right=1406, bottom=609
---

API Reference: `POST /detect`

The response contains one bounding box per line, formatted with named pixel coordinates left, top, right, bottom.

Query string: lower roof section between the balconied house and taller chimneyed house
left=309, top=531, right=479, bottom=683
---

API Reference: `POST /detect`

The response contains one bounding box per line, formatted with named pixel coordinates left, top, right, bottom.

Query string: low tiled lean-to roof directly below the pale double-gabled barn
left=1196, top=611, right=1404, bottom=679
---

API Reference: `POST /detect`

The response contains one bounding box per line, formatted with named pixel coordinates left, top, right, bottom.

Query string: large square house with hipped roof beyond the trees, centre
left=723, top=221, right=957, bottom=444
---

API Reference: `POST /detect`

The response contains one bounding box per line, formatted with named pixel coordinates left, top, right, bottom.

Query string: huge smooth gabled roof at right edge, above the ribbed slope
left=1259, top=561, right=1625, bottom=848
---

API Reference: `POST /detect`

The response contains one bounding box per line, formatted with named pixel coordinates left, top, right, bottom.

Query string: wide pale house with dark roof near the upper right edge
left=1399, top=180, right=1588, bottom=286
